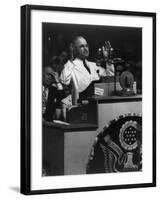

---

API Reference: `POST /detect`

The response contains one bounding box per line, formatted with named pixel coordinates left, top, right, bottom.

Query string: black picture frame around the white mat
left=21, top=5, right=156, bottom=194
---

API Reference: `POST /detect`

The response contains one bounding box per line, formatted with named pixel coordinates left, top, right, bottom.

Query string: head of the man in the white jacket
left=73, top=36, right=89, bottom=60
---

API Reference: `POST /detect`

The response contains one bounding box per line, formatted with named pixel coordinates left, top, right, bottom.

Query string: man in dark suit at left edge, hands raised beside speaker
left=42, top=65, right=65, bottom=121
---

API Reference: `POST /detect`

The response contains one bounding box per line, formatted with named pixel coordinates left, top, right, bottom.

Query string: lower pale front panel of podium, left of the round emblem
left=64, top=131, right=96, bottom=175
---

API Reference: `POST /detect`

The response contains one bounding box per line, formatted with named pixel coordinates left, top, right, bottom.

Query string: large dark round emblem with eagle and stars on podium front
left=87, top=113, right=142, bottom=173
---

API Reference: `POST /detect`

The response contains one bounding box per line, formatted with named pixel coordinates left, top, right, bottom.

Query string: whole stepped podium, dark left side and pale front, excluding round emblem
left=43, top=96, right=142, bottom=176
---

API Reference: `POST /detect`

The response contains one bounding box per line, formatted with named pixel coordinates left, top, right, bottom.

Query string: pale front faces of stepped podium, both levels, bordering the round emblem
left=64, top=101, right=142, bottom=175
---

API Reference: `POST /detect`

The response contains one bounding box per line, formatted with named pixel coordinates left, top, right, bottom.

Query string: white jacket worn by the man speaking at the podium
left=60, top=58, right=106, bottom=92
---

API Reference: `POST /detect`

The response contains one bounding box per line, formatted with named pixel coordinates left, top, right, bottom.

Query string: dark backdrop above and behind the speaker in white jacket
left=42, top=23, right=142, bottom=90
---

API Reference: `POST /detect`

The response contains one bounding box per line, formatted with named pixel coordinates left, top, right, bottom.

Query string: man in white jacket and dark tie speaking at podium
left=60, top=36, right=109, bottom=104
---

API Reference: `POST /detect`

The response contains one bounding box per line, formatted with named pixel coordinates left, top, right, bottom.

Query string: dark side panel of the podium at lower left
left=42, top=126, right=64, bottom=176
